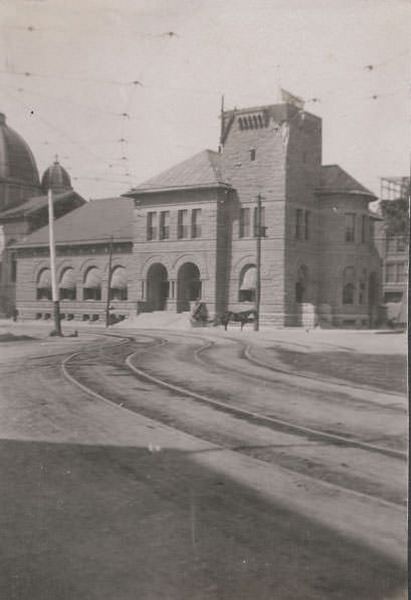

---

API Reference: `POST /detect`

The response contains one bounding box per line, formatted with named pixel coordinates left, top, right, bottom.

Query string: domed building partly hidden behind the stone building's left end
left=0, top=113, right=85, bottom=315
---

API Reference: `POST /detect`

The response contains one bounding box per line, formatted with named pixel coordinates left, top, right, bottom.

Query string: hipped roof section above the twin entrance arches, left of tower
left=127, top=150, right=229, bottom=196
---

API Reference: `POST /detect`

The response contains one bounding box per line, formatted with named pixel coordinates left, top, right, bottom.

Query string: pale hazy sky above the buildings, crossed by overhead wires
left=0, top=0, right=411, bottom=199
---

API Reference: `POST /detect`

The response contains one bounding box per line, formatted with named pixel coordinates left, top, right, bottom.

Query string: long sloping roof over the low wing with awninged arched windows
left=15, top=197, right=134, bottom=247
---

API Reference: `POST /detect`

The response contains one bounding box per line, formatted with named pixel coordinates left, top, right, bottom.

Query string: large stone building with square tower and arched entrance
left=16, top=98, right=380, bottom=327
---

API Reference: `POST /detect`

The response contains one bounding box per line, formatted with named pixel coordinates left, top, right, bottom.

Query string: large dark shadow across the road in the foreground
left=0, top=440, right=405, bottom=600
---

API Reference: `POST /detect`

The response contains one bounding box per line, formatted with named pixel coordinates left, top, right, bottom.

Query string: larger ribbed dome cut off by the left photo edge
left=0, top=113, right=39, bottom=186
